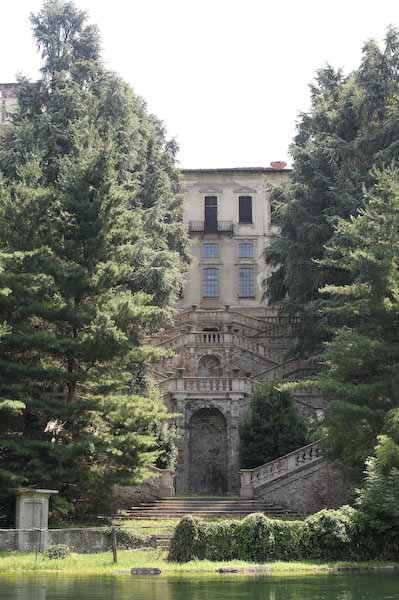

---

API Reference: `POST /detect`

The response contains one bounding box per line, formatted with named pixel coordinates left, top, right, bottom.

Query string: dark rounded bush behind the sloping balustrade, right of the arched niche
left=240, top=384, right=307, bottom=469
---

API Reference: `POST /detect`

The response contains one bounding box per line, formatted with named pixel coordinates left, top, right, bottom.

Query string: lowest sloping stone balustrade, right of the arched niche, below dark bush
left=240, top=440, right=322, bottom=498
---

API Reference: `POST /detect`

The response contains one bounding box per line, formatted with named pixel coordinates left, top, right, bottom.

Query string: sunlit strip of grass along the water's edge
left=0, top=550, right=394, bottom=577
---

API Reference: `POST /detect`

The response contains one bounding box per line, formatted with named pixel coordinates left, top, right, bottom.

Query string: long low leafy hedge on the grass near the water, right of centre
left=168, top=506, right=389, bottom=562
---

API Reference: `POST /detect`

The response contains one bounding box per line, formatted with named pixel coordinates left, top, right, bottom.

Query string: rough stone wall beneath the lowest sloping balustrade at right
left=255, top=459, right=352, bottom=515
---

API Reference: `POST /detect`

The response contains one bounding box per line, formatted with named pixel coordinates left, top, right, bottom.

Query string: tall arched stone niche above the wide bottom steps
left=189, top=408, right=227, bottom=496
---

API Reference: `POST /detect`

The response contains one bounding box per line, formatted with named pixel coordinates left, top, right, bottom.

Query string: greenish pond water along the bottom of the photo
left=0, top=573, right=399, bottom=600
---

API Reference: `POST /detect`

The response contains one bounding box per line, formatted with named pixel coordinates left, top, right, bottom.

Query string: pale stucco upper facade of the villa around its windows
left=179, top=168, right=289, bottom=311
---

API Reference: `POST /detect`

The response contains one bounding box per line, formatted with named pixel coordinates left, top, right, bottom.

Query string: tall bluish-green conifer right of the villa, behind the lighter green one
left=266, top=28, right=399, bottom=356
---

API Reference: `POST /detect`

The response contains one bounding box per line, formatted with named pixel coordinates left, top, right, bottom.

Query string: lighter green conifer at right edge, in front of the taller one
left=317, top=167, right=399, bottom=476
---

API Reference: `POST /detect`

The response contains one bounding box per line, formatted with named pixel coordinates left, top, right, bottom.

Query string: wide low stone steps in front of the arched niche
left=118, top=497, right=298, bottom=520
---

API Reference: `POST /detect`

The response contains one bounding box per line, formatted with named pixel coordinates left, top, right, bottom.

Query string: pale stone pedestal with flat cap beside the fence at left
left=16, top=488, right=58, bottom=551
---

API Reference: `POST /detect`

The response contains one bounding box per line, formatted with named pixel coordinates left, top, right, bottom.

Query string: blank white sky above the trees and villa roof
left=0, top=0, right=399, bottom=168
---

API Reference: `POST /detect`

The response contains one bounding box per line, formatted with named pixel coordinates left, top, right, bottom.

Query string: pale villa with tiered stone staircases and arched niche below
left=152, top=162, right=323, bottom=495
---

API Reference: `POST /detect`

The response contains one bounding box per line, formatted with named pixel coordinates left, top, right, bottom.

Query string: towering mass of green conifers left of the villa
left=0, top=0, right=185, bottom=516
